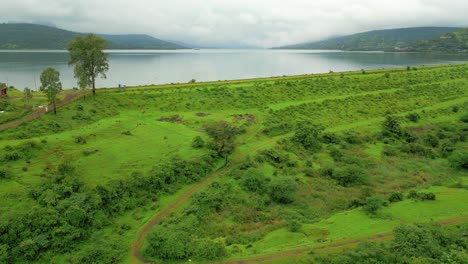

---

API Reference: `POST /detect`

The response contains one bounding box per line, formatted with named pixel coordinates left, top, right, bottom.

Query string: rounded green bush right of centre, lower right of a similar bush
left=269, top=177, right=297, bottom=204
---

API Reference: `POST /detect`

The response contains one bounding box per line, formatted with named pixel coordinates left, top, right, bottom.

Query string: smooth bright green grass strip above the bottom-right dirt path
left=227, top=187, right=468, bottom=259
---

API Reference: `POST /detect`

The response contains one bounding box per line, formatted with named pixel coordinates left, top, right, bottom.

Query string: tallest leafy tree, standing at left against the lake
left=67, top=34, right=109, bottom=95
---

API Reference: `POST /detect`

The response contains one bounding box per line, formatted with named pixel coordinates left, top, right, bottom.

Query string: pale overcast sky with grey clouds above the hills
left=0, top=0, right=468, bottom=47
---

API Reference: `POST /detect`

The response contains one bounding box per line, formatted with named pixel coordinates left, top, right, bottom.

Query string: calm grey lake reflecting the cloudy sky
left=0, top=50, right=468, bottom=90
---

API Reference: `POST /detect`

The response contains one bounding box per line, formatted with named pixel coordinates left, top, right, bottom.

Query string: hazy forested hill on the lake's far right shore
left=280, top=27, right=460, bottom=51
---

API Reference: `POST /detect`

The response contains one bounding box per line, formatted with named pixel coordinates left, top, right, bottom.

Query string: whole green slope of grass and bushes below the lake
left=0, top=64, right=468, bottom=263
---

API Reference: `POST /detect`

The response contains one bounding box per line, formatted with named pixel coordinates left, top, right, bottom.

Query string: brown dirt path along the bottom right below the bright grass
left=215, top=216, right=468, bottom=264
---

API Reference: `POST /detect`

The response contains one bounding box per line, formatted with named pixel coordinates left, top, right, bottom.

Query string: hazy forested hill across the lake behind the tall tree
left=0, top=23, right=185, bottom=49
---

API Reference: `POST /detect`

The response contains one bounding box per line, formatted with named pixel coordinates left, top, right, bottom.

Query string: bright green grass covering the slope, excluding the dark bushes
left=0, top=65, right=468, bottom=263
